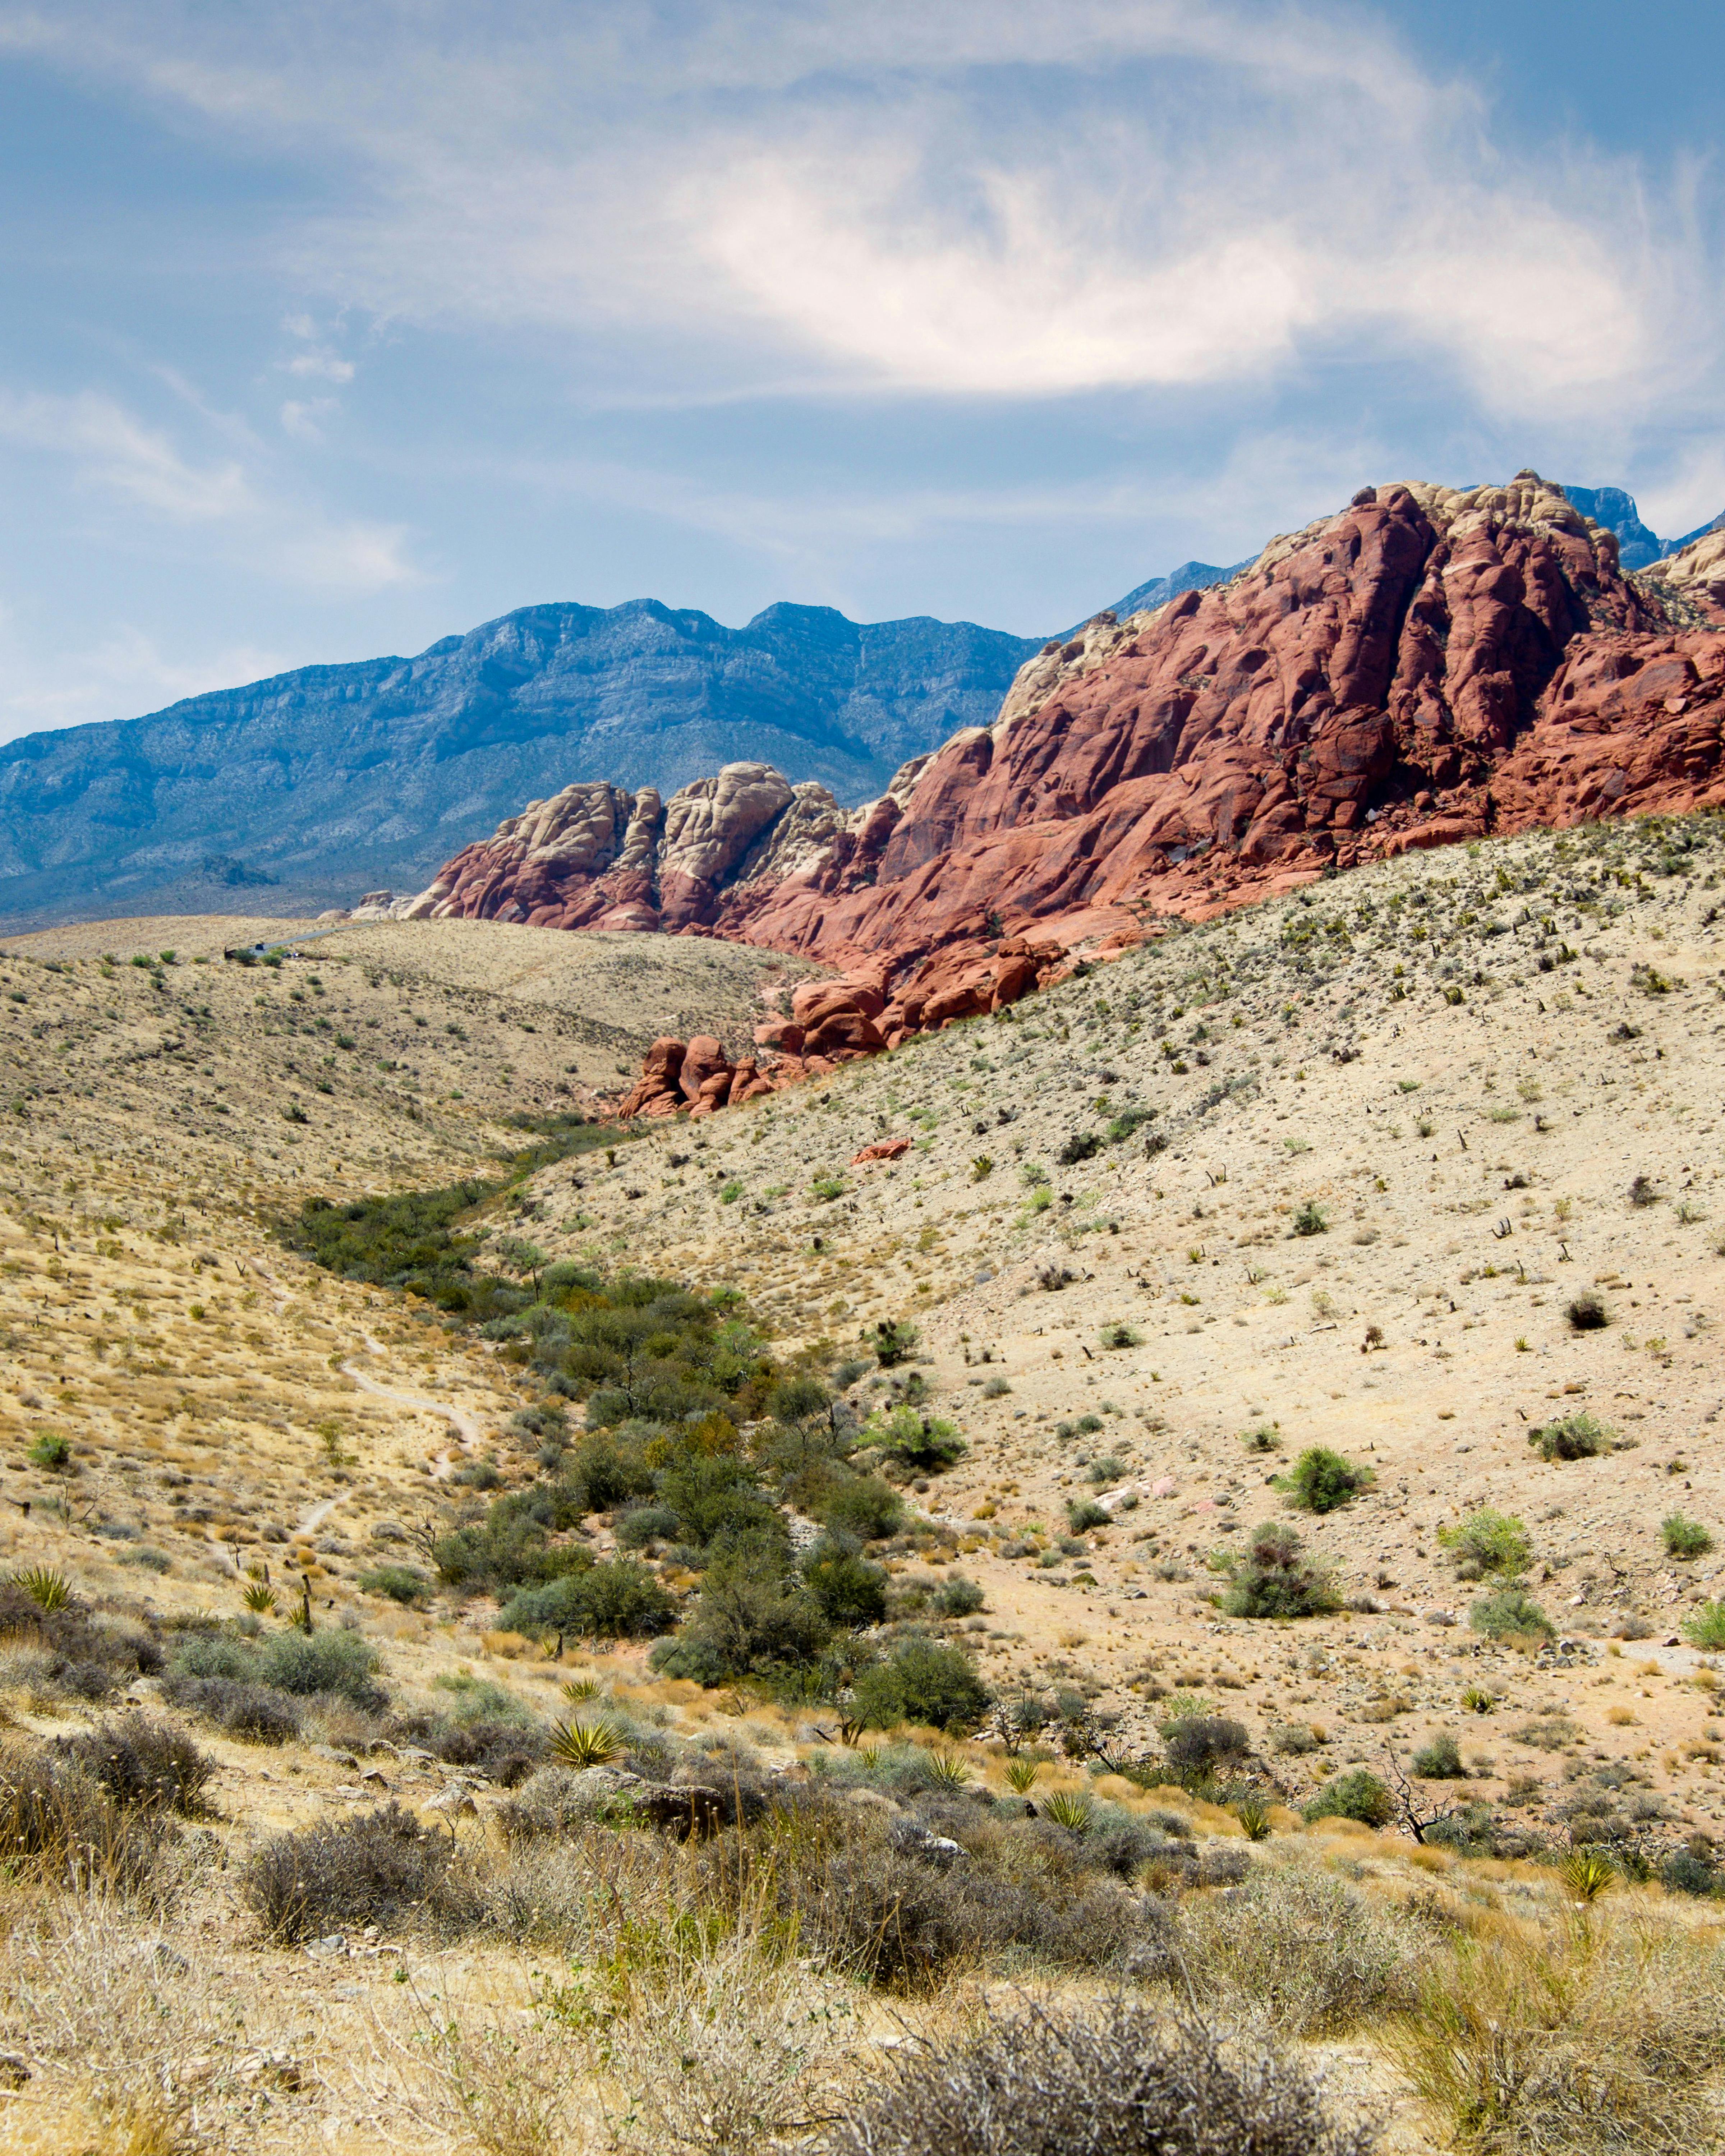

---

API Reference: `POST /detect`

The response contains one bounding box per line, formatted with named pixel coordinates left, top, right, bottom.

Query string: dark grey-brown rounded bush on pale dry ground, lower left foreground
left=239, top=1802, right=468, bottom=1945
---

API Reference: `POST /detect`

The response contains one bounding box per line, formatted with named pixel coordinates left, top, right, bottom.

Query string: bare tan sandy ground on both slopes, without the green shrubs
left=0, top=819, right=1725, bottom=2156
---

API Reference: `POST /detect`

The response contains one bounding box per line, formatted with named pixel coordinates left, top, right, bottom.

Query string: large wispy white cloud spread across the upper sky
left=27, top=0, right=1721, bottom=420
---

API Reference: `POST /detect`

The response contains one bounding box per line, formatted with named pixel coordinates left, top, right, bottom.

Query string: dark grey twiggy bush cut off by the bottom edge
left=819, top=1996, right=1376, bottom=2156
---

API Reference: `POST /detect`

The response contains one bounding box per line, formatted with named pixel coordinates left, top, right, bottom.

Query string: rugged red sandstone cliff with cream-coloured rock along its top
left=405, top=472, right=1725, bottom=983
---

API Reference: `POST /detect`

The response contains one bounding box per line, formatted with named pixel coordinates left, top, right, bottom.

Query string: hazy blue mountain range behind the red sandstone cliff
left=0, top=487, right=1708, bottom=929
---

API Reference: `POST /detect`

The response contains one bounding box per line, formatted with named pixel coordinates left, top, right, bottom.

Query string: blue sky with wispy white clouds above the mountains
left=0, top=0, right=1725, bottom=740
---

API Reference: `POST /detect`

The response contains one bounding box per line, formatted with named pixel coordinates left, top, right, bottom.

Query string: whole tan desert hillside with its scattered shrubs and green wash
left=0, top=817, right=1725, bottom=2156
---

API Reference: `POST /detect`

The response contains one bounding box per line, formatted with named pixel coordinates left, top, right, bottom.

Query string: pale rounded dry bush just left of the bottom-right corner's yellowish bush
left=1179, top=1865, right=1423, bottom=2037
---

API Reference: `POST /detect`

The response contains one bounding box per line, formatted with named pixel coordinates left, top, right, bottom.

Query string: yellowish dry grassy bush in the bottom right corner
left=1386, top=1910, right=1725, bottom=2156
